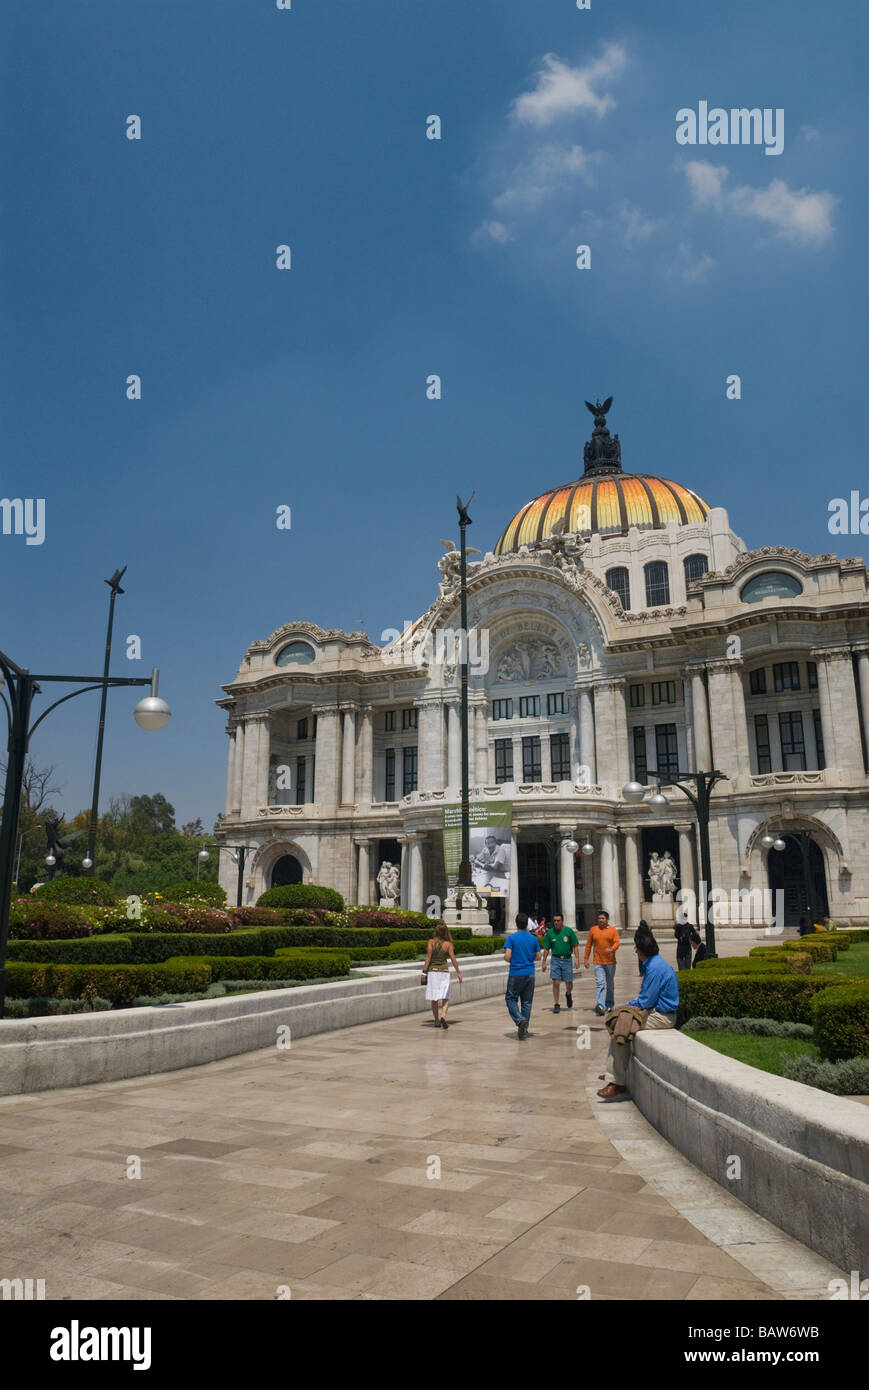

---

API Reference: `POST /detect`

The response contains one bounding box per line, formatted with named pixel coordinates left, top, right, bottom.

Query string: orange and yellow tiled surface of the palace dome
left=495, top=473, right=709, bottom=555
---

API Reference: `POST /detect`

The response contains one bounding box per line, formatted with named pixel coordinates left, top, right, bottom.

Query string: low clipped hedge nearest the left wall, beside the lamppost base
left=6, top=958, right=211, bottom=1005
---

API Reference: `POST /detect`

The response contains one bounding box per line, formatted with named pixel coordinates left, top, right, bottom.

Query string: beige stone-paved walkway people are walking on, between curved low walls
left=0, top=945, right=838, bottom=1301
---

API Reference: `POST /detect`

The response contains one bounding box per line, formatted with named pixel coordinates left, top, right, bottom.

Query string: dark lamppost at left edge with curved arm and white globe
left=0, top=644, right=171, bottom=1017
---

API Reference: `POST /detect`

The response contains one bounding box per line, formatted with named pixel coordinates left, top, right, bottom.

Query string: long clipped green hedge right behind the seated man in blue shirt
left=677, top=970, right=851, bottom=1026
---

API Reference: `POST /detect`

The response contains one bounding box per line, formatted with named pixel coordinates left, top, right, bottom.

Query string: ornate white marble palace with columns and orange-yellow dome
left=216, top=400, right=869, bottom=927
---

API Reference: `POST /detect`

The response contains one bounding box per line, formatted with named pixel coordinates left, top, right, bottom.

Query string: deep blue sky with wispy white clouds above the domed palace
left=0, top=0, right=869, bottom=826
